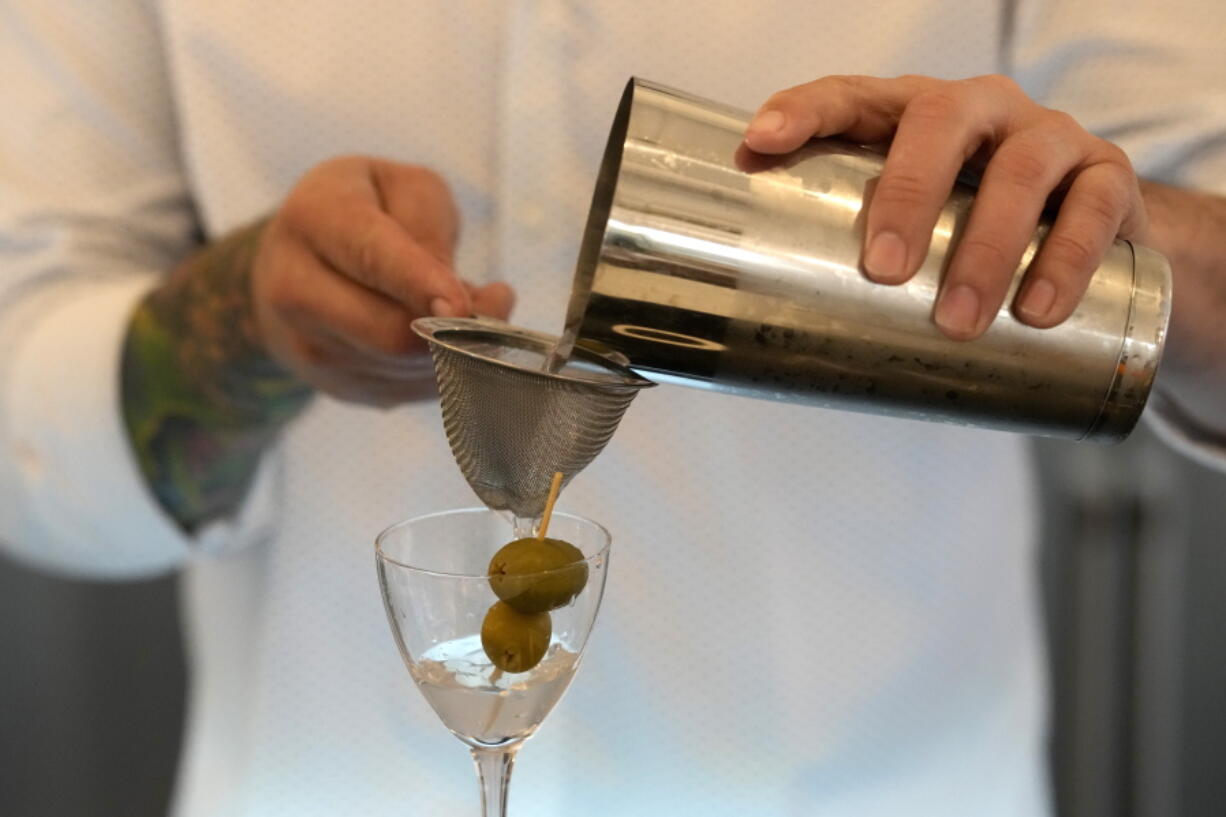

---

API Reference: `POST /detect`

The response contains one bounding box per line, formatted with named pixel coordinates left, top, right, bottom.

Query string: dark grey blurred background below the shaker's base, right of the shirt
left=1035, top=423, right=1226, bottom=817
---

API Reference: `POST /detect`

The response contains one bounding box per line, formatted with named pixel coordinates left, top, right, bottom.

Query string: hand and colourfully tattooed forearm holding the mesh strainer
left=120, top=157, right=511, bottom=531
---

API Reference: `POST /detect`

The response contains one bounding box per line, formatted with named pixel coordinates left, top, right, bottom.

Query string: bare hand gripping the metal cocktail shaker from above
left=745, top=76, right=1149, bottom=340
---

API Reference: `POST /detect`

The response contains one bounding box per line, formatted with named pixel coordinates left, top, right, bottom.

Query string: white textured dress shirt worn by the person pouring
left=0, top=0, right=1226, bottom=817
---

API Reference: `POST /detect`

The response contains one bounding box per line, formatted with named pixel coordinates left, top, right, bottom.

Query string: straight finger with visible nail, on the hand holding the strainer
left=287, top=193, right=471, bottom=316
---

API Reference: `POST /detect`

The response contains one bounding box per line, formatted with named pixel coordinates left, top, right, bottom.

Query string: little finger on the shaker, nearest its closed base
left=1015, top=157, right=1145, bottom=329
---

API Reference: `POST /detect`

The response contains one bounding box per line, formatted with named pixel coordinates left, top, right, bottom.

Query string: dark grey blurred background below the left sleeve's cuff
left=0, top=558, right=184, bottom=817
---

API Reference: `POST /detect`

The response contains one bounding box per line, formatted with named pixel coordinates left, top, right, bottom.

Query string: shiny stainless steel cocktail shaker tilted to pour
left=566, top=80, right=1171, bottom=440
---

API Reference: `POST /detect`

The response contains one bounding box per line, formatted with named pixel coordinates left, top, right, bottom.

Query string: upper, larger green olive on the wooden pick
left=489, top=537, right=587, bottom=613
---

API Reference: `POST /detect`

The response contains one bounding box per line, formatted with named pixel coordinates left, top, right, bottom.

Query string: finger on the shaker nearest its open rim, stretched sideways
left=745, top=76, right=940, bottom=153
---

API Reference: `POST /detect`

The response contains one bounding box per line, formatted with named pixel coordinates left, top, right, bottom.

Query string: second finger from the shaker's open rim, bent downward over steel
left=864, top=82, right=1007, bottom=283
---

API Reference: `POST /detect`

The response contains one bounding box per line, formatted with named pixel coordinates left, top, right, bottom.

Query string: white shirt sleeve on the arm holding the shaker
left=1007, top=0, right=1226, bottom=470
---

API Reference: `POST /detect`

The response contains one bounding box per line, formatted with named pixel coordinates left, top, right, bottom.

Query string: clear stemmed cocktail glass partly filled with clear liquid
left=375, top=508, right=611, bottom=817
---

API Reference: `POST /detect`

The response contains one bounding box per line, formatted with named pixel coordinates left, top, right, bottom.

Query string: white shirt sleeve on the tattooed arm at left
left=0, top=0, right=276, bottom=578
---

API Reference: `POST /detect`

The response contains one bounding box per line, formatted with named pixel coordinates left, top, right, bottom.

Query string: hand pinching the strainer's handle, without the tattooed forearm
left=251, top=156, right=514, bottom=406
